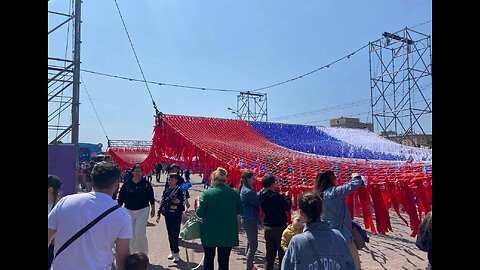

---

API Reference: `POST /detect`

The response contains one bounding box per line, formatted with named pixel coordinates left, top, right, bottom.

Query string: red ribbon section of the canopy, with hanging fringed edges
left=108, top=115, right=432, bottom=235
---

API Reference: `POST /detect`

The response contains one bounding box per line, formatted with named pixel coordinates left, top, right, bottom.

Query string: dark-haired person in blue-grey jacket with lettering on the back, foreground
left=282, top=192, right=355, bottom=270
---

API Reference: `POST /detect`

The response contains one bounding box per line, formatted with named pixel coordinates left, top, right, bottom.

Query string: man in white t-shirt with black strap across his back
left=48, top=162, right=132, bottom=270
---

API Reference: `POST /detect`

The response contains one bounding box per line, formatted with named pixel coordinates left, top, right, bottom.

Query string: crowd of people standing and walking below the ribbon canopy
left=48, top=162, right=432, bottom=270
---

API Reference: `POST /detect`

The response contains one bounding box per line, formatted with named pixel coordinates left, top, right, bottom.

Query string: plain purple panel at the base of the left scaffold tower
left=48, top=144, right=78, bottom=196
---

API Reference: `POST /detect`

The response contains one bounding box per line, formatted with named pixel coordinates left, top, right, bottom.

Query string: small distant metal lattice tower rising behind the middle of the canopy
left=236, top=92, right=268, bottom=122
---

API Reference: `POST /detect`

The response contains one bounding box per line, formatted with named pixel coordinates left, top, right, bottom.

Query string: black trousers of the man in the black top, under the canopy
left=264, top=226, right=286, bottom=270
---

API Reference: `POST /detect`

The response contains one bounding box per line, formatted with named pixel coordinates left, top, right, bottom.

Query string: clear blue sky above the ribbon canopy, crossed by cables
left=48, top=0, right=432, bottom=148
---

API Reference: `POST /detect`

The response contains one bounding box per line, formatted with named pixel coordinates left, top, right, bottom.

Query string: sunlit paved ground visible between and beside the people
left=136, top=175, right=428, bottom=270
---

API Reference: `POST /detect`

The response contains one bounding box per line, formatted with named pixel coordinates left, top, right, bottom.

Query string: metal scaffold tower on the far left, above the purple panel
left=48, top=0, right=82, bottom=144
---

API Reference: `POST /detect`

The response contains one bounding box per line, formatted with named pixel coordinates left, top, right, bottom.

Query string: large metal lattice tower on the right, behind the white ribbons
left=369, top=28, right=432, bottom=145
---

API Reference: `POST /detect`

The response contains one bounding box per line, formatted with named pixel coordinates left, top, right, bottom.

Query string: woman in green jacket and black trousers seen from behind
left=196, top=167, right=242, bottom=270
